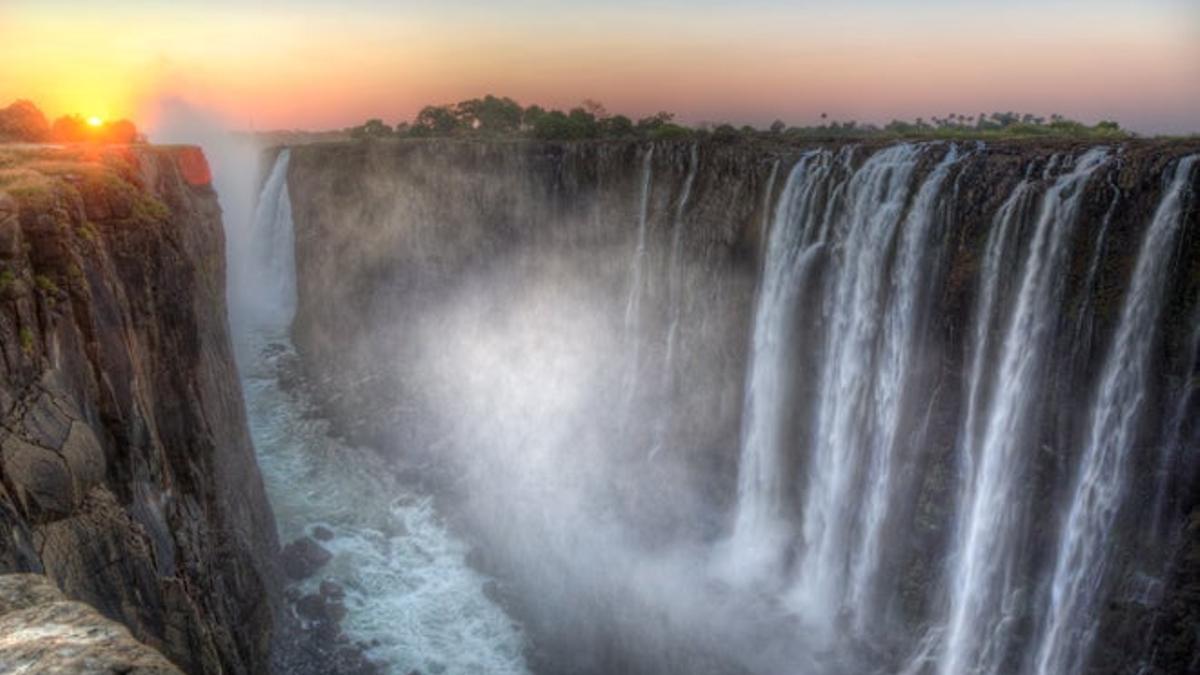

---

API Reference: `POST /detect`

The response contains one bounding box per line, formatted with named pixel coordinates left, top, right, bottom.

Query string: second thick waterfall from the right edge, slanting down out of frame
left=940, top=149, right=1108, bottom=675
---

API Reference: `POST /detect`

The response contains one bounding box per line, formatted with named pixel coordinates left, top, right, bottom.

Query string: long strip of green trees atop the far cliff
left=346, top=94, right=1132, bottom=143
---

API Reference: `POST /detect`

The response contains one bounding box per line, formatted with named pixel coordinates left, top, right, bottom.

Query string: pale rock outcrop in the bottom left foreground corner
left=0, top=574, right=182, bottom=675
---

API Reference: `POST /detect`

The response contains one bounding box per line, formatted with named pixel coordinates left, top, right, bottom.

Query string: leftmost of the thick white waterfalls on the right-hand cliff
left=732, top=153, right=832, bottom=577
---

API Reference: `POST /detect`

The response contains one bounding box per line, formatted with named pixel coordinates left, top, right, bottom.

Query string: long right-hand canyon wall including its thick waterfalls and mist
left=288, top=141, right=1200, bottom=673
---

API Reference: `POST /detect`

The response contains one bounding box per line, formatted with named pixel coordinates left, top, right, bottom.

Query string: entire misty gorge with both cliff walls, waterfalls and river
left=0, top=133, right=1200, bottom=675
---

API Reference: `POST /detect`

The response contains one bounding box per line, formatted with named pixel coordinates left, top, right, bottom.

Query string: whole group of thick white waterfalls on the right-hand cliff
left=721, top=139, right=1200, bottom=675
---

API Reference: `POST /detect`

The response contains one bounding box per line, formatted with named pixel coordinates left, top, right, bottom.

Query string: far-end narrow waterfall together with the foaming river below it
left=230, top=151, right=528, bottom=675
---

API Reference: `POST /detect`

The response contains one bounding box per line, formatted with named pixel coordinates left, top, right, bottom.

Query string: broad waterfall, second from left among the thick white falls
left=796, top=144, right=919, bottom=616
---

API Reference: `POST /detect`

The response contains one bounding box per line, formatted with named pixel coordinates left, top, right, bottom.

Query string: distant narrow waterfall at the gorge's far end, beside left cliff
left=232, top=149, right=296, bottom=327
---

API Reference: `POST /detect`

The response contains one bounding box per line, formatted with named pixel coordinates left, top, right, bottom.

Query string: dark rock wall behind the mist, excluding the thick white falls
left=288, top=141, right=1200, bottom=671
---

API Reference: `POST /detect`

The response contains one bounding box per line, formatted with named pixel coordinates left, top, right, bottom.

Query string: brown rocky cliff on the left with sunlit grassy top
left=0, top=147, right=277, bottom=673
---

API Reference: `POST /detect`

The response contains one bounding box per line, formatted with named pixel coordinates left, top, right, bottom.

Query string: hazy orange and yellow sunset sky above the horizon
left=0, top=0, right=1200, bottom=133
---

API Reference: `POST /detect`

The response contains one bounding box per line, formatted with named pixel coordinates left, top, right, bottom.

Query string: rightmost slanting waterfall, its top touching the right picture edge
left=1037, top=155, right=1198, bottom=675
